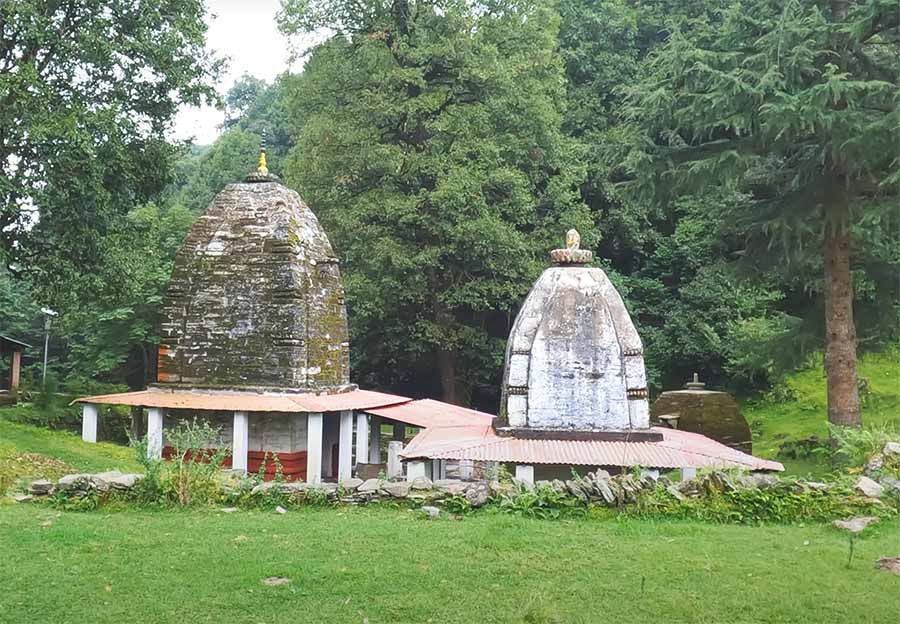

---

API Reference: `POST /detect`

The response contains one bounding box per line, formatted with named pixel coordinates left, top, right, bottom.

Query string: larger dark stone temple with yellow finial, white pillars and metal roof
left=78, top=145, right=492, bottom=482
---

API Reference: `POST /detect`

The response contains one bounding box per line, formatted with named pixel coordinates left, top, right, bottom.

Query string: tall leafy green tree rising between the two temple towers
left=281, top=0, right=596, bottom=406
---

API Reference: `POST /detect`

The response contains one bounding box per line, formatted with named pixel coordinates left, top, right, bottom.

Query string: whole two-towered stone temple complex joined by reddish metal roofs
left=78, top=146, right=782, bottom=483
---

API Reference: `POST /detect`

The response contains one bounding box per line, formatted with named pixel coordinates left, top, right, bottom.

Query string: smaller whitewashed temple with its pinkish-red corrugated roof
left=402, top=230, right=783, bottom=481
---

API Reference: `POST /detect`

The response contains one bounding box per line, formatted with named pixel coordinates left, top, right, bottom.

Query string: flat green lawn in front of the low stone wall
left=0, top=505, right=900, bottom=624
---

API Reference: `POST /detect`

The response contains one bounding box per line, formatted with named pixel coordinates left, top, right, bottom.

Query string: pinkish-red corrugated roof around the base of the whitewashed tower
left=401, top=425, right=784, bottom=471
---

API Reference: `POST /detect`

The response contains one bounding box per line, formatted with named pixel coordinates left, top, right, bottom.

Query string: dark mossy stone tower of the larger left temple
left=157, top=178, right=350, bottom=390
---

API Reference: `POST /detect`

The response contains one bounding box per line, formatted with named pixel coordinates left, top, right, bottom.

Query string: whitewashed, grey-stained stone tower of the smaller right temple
left=497, top=230, right=649, bottom=433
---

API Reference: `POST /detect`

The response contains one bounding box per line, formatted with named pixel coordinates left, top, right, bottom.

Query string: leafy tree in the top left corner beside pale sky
left=0, top=0, right=219, bottom=268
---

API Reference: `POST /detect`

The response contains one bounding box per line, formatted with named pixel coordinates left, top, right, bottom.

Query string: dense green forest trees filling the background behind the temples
left=0, top=0, right=900, bottom=420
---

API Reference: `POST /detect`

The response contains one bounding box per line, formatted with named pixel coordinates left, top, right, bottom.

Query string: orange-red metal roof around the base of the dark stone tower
left=73, top=388, right=409, bottom=412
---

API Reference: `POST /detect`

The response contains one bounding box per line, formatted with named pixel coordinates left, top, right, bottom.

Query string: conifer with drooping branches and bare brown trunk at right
left=617, top=0, right=900, bottom=426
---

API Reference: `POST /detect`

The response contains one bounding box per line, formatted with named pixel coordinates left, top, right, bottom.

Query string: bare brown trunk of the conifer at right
left=824, top=220, right=862, bottom=427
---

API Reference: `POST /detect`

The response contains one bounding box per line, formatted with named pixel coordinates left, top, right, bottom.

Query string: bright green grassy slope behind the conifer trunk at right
left=742, top=346, right=900, bottom=475
